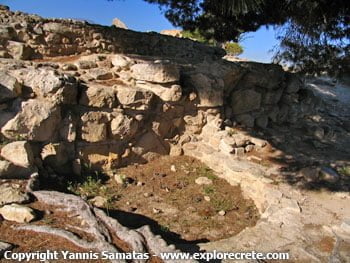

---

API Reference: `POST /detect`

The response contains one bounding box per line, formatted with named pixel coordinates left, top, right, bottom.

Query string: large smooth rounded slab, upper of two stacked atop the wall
left=131, top=63, right=180, bottom=83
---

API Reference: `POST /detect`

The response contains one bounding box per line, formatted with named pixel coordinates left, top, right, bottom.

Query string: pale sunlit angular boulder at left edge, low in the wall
left=1, top=141, right=34, bottom=168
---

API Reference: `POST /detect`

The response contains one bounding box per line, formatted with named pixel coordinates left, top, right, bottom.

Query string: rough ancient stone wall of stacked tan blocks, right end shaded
left=0, top=7, right=317, bottom=177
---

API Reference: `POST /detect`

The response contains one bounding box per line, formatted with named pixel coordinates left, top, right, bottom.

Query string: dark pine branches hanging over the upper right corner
left=145, top=0, right=350, bottom=75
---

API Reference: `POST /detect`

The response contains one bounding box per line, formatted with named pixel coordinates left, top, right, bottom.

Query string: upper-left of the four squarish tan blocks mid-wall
left=79, top=84, right=117, bottom=108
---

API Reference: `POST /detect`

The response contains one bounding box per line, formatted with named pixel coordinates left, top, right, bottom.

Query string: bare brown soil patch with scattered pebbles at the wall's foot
left=73, top=156, right=259, bottom=242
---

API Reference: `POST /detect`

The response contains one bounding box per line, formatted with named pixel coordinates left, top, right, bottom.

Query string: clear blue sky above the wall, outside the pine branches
left=0, top=0, right=278, bottom=62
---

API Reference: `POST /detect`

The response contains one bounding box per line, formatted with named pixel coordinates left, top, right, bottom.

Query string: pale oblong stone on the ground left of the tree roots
left=0, top=204, right=36, bottom=223
